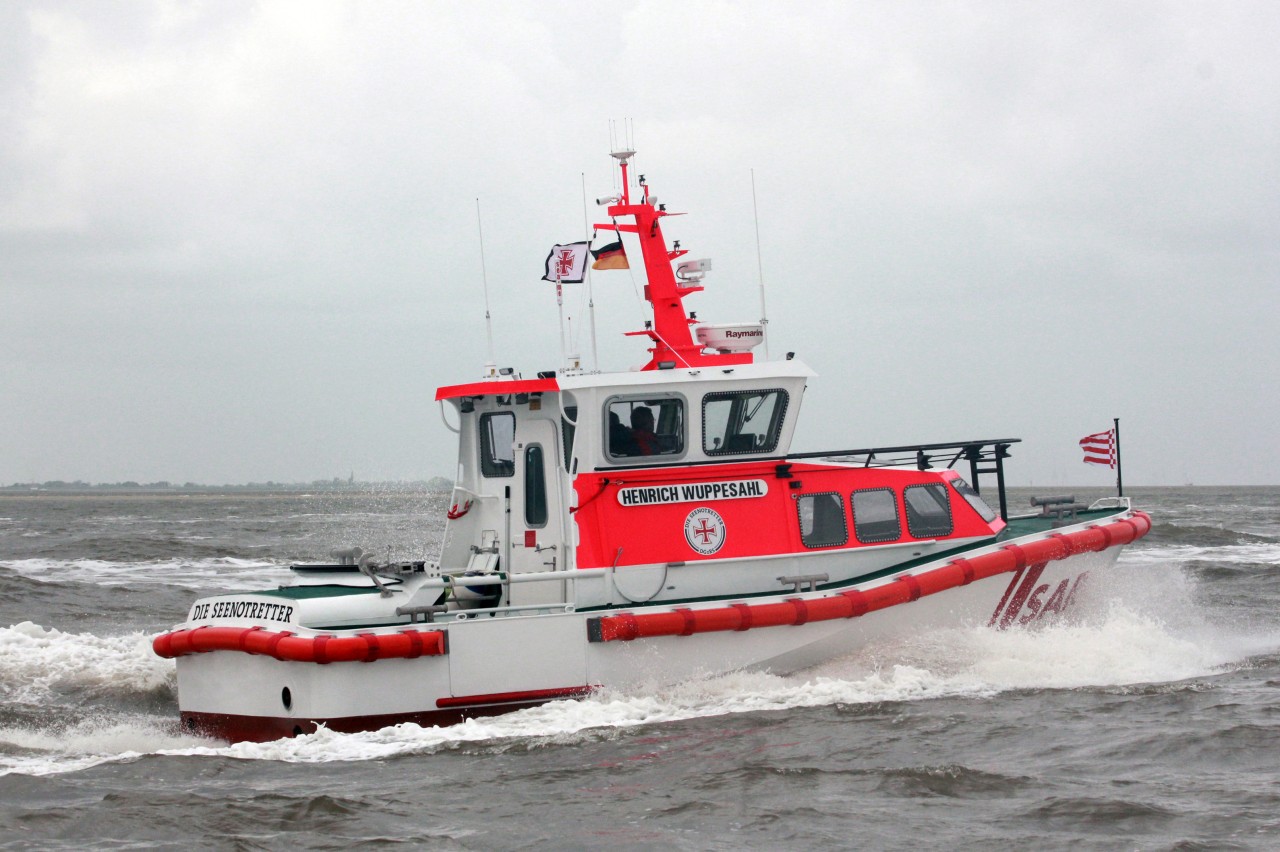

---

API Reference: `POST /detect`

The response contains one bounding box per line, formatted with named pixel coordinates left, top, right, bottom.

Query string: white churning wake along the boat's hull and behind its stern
left=0, top=591, right=1280, bottom=775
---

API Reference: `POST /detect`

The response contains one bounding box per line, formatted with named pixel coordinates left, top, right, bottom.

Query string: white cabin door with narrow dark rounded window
left=511, top=420, right=564, bottom=606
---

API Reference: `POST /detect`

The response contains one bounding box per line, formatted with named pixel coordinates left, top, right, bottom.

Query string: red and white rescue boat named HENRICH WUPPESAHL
left=154, top=151, right=1151, bottom=741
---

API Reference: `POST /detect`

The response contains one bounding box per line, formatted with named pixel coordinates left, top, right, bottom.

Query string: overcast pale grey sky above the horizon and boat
left=0, top=1, right=1280, bottom=485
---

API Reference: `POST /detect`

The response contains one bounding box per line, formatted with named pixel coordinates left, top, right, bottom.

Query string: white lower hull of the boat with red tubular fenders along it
left=156, top=510, right=1151, bottom=741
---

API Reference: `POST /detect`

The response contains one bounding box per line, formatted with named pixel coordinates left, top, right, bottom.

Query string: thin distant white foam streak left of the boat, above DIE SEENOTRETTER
left=0, top=556, right=293, bottom=591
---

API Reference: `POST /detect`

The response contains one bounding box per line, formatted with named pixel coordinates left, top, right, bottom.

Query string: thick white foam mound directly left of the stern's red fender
left=0, top=622, right=174, bottom=704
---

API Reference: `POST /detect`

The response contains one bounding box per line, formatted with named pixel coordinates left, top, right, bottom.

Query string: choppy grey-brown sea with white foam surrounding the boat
left=0, top=487, right=1280, bottom=849
